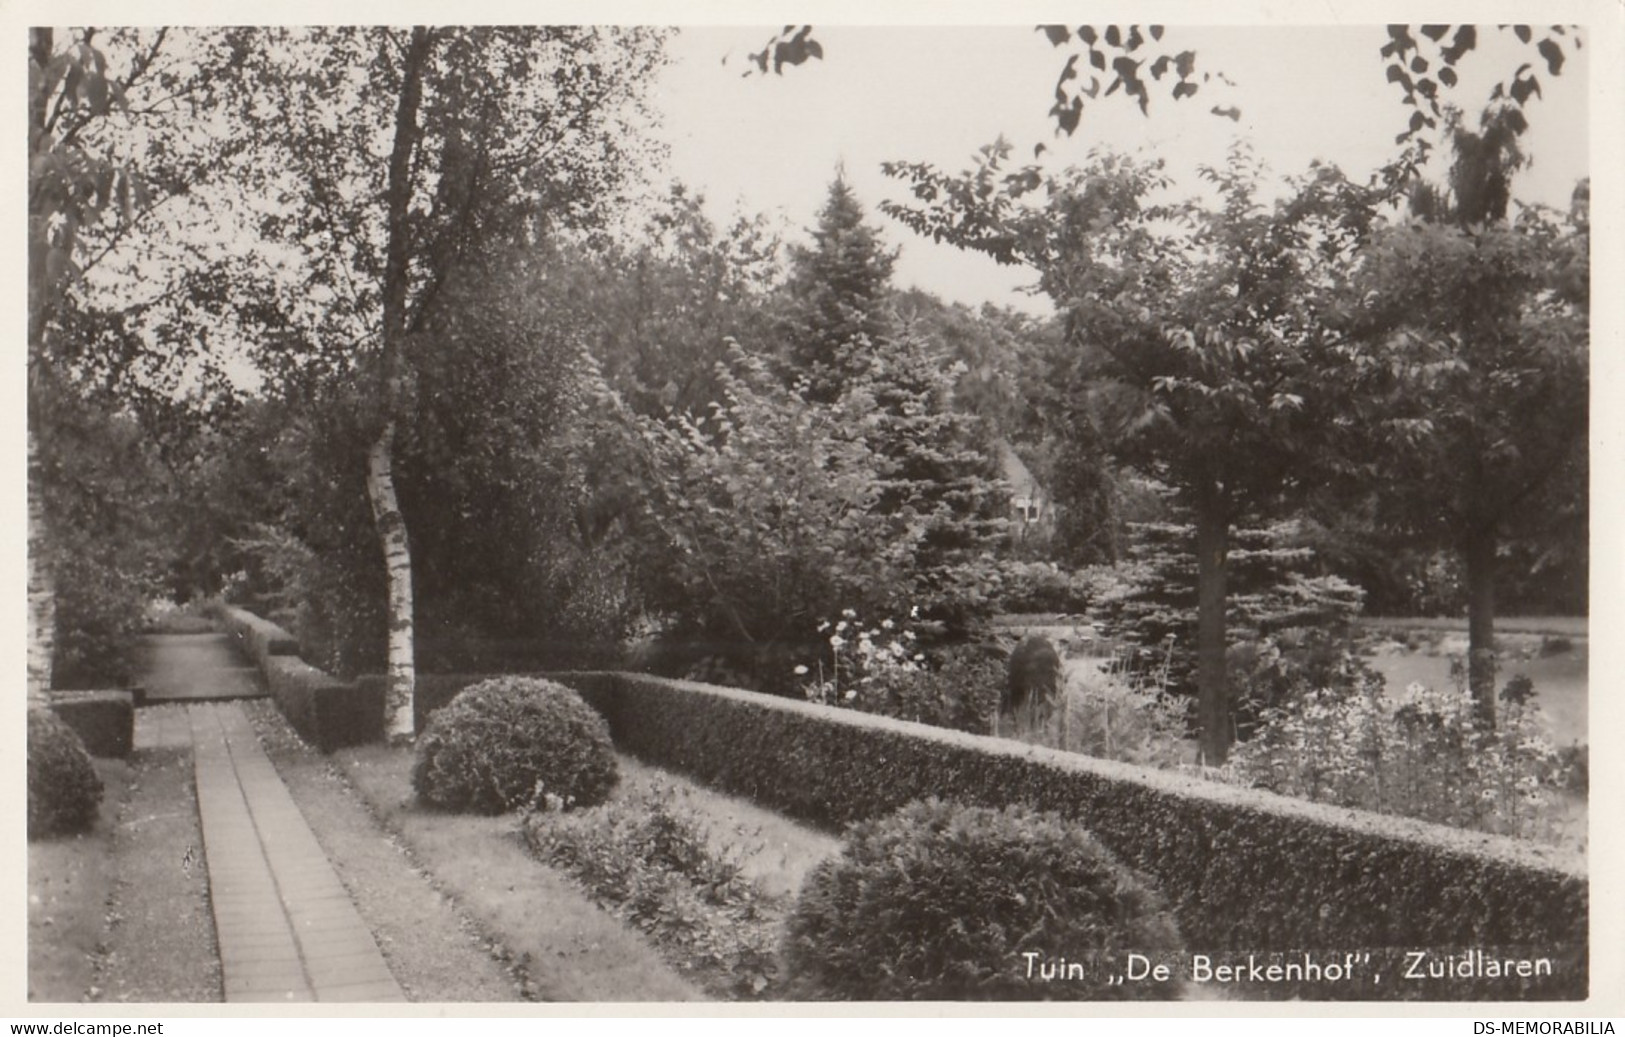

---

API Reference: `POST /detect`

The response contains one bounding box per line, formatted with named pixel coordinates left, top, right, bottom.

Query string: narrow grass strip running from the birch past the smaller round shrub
left=333, top=744, right=702, bottom=1003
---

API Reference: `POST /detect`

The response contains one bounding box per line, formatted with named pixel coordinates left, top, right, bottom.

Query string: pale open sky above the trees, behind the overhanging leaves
left=653, top=23, right=1589, bottom=312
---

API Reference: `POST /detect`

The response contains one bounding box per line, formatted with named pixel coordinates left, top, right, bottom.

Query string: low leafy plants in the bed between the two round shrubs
left=520, top=783, right=783, bottom=998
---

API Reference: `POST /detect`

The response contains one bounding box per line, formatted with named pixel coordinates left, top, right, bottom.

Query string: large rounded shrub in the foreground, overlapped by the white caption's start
left=785, top=800, right=1180, bottom=1001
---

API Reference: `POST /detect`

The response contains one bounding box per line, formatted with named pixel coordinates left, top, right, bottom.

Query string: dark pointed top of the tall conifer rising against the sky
left=783, top=171, right=897, bottom=403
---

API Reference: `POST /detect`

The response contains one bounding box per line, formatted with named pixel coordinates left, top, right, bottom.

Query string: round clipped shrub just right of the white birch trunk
left=411, top=676, right=619, bottom=814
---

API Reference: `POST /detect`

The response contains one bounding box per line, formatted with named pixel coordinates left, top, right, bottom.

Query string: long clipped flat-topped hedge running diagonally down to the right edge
left=556, top=673, right=1589, bottom=1000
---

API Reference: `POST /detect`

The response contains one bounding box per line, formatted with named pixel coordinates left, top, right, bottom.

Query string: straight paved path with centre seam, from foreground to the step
left=187, top=702, right=406, bottom=1001
